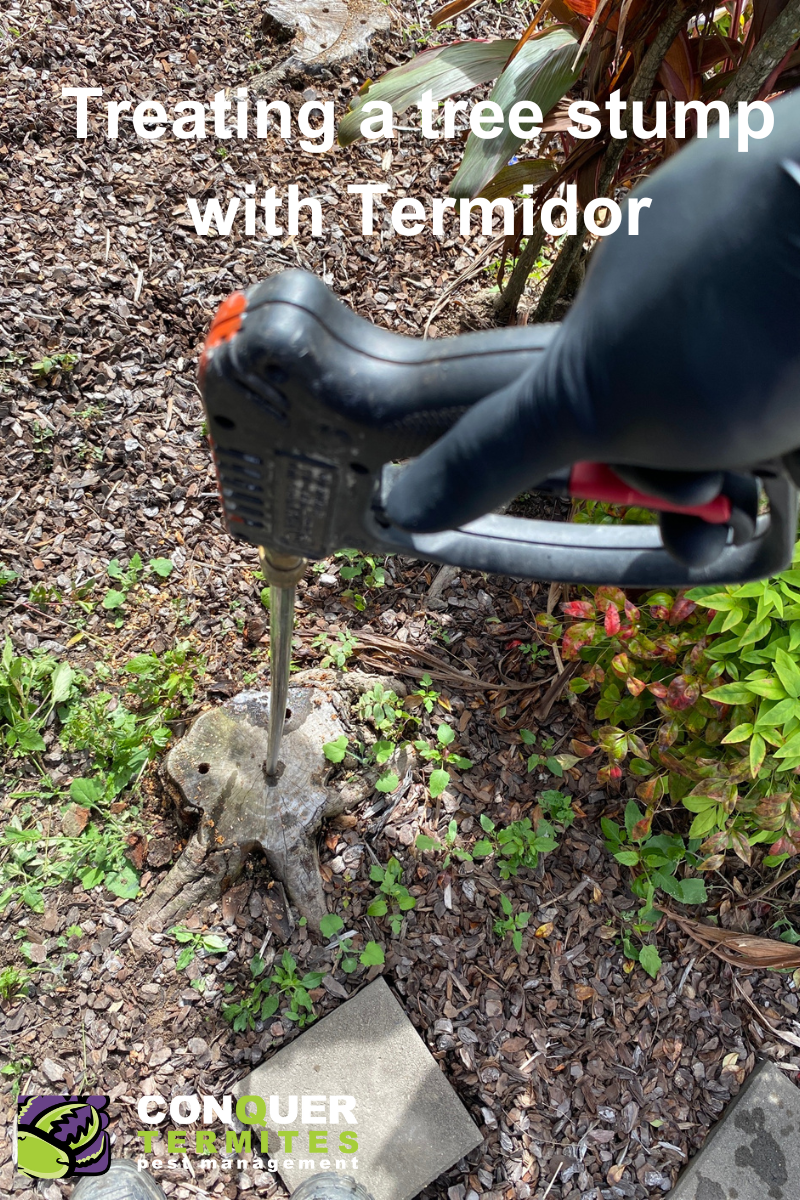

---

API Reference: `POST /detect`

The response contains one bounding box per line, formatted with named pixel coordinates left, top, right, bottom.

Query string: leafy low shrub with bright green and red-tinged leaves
left=537, top=547, right=800, bottom=892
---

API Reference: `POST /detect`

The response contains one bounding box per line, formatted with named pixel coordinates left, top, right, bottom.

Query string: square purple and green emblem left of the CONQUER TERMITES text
left=17, top=1096, right=112, bottom=1180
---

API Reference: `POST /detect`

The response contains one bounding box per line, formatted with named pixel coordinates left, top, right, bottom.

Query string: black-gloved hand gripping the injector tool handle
left=386, top=94, right=800, bottom=565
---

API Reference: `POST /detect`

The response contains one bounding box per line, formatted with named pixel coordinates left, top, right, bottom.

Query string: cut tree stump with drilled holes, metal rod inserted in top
left=136, top=670, right=407, bottom=934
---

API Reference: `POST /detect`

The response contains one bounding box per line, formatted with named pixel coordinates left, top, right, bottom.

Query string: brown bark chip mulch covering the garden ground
left=0, top=0, right=800, bottom=1200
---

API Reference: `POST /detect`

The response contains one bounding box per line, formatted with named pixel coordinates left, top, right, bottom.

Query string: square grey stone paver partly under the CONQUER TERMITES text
left=234, top=979, right=482, bottom=1200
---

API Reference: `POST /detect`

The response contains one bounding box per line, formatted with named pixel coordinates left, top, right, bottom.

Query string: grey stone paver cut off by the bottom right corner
left=668, top=1062, right=800, bottom=1200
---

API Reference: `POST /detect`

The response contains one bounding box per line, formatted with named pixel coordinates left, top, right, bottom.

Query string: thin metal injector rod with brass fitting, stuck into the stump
left=258, top=546, right=307, bottom=778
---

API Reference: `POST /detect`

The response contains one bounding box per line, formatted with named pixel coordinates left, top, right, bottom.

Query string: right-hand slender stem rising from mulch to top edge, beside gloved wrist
left=534, top=0, right=700, bottom=322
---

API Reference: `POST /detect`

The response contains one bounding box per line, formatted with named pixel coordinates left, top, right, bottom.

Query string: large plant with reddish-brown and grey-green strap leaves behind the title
left=338, top=0, right=800, bottom=320
